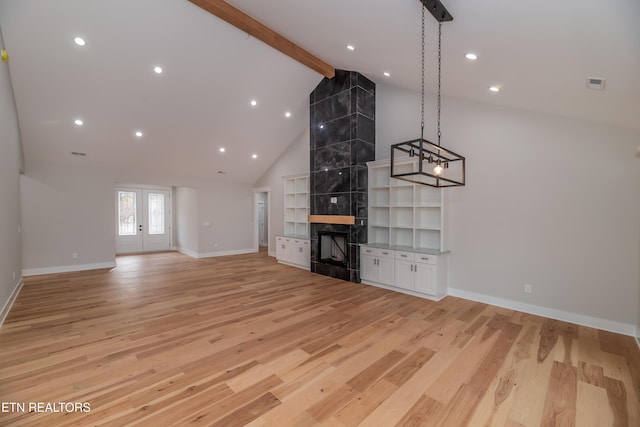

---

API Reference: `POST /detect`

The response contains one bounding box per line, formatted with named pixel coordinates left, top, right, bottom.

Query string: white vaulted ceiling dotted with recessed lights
left=0, top=0, right=640, bottom=183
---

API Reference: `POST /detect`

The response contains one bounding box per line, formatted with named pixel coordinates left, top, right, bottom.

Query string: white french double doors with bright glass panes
left=116, top=188, right=171, bottom=254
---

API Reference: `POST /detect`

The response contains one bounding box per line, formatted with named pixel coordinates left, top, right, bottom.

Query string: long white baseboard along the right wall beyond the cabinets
left=449, top=288, right=635, bottom=336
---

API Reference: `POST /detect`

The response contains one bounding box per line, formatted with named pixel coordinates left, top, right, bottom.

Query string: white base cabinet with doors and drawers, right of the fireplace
left=360, top=245, right=448, bottom=300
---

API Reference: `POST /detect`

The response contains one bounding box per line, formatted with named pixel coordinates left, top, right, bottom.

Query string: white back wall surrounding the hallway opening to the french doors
left=21, top=159, right=253, bottom=274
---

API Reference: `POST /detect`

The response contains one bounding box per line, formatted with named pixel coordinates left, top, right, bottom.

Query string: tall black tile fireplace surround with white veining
left=309, top=70, right=375, bottom=282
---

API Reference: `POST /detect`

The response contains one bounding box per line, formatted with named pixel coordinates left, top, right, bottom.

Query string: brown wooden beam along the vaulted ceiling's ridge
left=189, top=0, right=336, bottom=79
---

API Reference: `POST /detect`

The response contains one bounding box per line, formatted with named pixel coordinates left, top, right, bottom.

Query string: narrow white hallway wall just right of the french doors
left=174, top=187, right=200, bottom=256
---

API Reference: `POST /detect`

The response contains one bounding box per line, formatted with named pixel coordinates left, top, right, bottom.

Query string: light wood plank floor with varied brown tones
left=0, top=253, right=640, bottom=427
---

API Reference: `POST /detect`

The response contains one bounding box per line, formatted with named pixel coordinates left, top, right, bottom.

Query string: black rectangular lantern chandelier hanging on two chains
left=391, top=0, right=465, bottom=187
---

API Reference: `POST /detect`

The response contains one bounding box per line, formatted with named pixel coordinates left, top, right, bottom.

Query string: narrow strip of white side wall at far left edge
left=0, top=28, right=22, bottom=324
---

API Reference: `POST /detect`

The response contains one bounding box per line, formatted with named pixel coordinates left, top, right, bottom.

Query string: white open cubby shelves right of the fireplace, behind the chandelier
left=367, top=160, right=446, bottom=252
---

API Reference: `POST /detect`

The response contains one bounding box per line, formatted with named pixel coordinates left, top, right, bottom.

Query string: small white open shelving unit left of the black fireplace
left=283, top=174, right=309, bottom=238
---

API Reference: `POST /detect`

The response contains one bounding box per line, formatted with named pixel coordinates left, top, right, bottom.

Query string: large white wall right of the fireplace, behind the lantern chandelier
left=376, top=85, right=640, bottom=334
